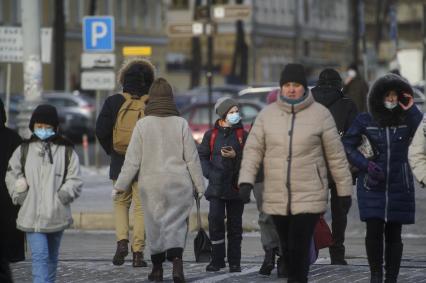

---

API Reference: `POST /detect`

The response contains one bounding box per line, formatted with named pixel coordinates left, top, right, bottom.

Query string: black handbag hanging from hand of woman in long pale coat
left=194, top=197, right=212, bottom=262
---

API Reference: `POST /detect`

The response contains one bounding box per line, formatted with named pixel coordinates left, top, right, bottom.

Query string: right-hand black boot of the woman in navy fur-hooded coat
left=385, top=243, right=403, bottom=283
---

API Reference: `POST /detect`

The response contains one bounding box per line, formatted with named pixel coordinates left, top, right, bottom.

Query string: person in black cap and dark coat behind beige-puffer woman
left=312, top=69, right=358, bottom=265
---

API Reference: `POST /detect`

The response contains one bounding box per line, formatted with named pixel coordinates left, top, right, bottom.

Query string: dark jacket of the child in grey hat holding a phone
left=198, top=120, right=248, bottom=199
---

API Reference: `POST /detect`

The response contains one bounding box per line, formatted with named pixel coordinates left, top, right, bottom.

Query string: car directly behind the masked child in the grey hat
left=181, top=100, right=265, bottom=144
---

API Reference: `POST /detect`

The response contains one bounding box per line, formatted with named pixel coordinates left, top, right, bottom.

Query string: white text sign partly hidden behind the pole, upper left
left=0, top=27, right=52, bottom=63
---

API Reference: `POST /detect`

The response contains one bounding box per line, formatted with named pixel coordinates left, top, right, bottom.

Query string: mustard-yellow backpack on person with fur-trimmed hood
left=112, top=93, right=149, bottom=155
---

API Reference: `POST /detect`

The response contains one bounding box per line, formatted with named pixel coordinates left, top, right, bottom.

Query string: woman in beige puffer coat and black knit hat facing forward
left=238, top=64, right=352, bottom=282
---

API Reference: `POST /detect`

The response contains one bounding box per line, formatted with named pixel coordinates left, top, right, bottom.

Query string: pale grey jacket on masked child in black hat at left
left=6, top=140, right=83, bottom=233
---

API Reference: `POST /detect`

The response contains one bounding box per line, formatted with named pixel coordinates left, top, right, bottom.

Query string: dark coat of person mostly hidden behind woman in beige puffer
left=311, top=86, right=358, bottom=185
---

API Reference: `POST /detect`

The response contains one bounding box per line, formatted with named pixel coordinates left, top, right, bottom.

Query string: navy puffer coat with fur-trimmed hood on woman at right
left=343, top=74, right=423, bottom=224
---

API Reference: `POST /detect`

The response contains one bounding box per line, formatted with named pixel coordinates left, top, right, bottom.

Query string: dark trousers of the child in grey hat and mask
left=209, top=198, right=244, bottom=265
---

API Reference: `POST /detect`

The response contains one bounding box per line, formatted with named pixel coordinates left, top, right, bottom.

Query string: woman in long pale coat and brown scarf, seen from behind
left=115, top=78, right=204, bottom=282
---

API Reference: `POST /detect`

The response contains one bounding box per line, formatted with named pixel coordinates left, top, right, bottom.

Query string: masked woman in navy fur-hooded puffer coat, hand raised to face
left=343, top=74, right=422, bottom=282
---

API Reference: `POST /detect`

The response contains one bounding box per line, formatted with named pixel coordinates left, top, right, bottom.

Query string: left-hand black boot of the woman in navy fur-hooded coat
left=365, top=239, right=383, bottom=283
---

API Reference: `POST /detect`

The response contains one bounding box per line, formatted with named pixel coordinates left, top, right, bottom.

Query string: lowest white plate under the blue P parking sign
left=81, top=70, right=115, bottom=90
